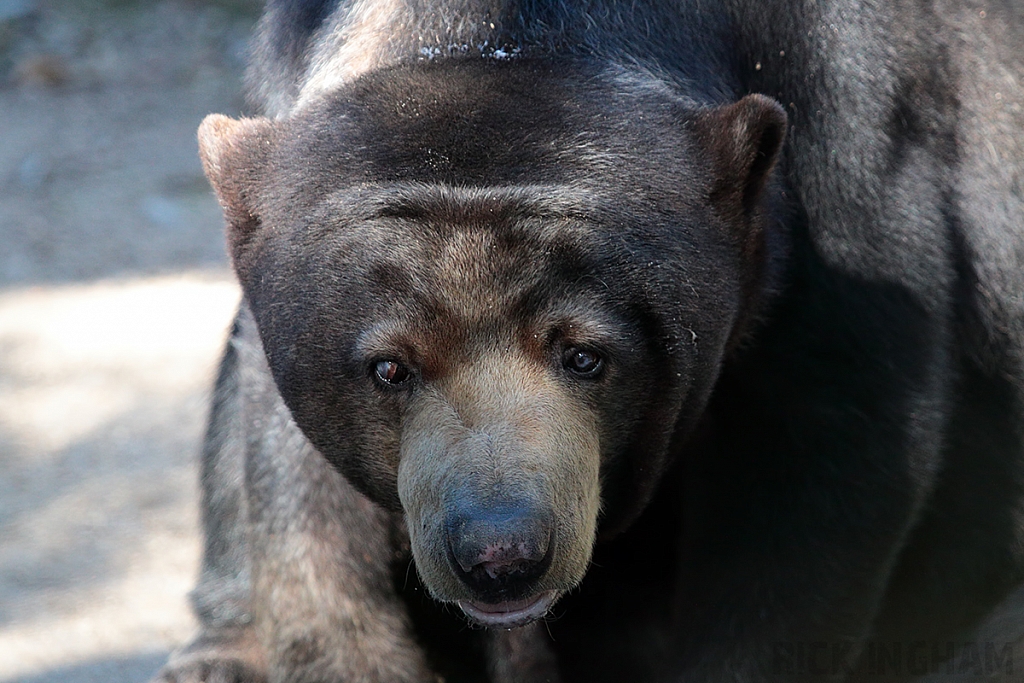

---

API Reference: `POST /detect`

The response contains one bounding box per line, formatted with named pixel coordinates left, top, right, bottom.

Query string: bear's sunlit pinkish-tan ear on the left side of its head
left=199, top=114, right=274, bottom=265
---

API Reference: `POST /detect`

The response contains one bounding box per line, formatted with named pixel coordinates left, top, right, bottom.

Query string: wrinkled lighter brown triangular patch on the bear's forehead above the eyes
left=328, top=183, right=608, bottom=326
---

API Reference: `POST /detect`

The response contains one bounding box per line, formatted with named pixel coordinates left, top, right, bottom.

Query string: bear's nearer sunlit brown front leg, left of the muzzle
left=240, top=305, right=436, bottom=683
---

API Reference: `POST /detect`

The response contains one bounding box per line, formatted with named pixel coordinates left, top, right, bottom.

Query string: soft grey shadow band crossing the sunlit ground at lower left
left=0, top=395, right=206, bottom=629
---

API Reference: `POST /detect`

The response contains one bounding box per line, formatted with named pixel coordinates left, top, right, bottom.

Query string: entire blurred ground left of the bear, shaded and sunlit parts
left=0, top=0, right=258, bottom=683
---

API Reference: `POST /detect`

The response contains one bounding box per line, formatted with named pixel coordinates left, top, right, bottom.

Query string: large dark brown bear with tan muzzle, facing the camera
left=151, top=0, right=1024, bottom=683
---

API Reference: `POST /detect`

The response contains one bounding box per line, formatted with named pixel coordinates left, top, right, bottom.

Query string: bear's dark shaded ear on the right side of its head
left=695, top=95, right=786, bottom=217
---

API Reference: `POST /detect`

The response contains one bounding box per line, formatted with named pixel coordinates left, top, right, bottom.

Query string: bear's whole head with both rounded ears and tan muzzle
left=201, top=61, right=784, bottom=628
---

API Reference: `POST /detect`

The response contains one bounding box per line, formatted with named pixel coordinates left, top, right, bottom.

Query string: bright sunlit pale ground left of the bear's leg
left=0, top=273, right=239, bottom=681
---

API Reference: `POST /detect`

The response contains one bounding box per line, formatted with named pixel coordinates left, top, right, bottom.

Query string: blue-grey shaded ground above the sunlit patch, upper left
left=0, top=0, right=257, bottom=287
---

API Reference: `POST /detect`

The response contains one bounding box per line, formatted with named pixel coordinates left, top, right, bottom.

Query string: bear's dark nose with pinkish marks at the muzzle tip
left=445, top=502, right=552, bottom=602
